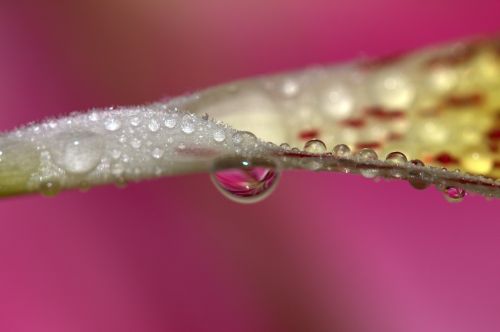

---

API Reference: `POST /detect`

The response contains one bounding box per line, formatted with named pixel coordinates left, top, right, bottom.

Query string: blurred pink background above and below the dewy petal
left=0, top=0, right=500, bottom=332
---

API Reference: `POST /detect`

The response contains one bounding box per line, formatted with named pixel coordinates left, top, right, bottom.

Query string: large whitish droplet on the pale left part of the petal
left=49, top=131, right=105, bottom=174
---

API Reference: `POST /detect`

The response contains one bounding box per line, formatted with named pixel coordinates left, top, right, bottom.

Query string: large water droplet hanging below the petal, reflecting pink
left=211, top=158, right=279, bottom=203
